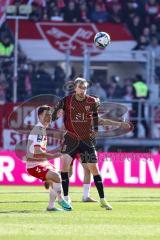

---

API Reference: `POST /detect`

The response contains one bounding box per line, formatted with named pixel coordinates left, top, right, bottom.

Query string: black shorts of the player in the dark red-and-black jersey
left=61, top=134, right=97, bottom=163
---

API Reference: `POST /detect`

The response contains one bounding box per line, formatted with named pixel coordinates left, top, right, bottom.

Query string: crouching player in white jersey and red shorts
left=26, top=105, right=72, bottom=211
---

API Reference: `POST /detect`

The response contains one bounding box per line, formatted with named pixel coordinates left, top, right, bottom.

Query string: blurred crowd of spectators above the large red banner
left=10, top=0, right=160, bottom=50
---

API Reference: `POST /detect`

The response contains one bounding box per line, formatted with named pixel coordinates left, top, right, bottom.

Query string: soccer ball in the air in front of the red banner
left=94, top=32, right=111, bottom=48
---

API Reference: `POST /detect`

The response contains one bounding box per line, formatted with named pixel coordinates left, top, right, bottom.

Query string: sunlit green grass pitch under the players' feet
left=0, top=186, right=160, bottom=240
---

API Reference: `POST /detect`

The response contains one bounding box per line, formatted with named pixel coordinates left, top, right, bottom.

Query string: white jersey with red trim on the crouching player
left=26, top=122, right=50, bottom=168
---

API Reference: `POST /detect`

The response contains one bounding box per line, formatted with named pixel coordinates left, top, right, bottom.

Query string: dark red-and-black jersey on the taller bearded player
left=52, top=94, right=100, bottom=139
